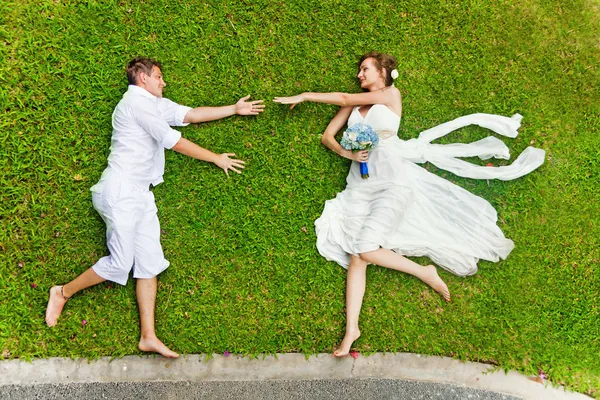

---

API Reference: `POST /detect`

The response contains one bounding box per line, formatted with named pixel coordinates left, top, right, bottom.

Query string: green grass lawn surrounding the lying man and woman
left=0, top=0, right=600, bottom=396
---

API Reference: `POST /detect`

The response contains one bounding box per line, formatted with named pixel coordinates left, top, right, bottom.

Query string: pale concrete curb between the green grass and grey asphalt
left=0, top=353, right=589, bottom=400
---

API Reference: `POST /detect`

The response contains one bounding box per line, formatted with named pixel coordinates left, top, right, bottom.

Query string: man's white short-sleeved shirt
left=91, top=85, right=191, bottom=192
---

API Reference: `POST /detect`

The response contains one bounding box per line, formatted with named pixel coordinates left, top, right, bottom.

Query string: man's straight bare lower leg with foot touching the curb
left=135, top=277, right=179, bottom=358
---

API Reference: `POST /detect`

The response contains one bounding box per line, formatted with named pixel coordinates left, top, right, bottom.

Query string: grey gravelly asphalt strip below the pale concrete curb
left=0, top=379, right=520, bottom=400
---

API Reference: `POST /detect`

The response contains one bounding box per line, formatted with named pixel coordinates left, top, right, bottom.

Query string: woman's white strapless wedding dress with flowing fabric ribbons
left=315, top=104, right=545, bottom=276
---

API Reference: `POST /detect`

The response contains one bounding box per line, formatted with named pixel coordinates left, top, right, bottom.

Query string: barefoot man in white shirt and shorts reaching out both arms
left=46, top=58, right=264, bottom=358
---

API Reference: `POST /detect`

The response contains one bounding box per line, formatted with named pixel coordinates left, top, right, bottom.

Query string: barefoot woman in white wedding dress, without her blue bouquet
left=274, top=52, right=543, bottom=357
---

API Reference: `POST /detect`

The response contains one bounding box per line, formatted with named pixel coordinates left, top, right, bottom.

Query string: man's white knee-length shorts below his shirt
left=92, top=178, right=169, bottom=285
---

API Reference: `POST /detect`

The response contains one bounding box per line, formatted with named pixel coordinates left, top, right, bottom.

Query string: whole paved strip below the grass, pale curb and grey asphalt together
left=0, top=353, right=589, bottom=400
